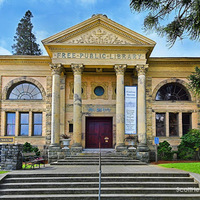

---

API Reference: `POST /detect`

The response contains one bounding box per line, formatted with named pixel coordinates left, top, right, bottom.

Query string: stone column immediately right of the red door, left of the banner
left=114, top=65, right=126, bottom=151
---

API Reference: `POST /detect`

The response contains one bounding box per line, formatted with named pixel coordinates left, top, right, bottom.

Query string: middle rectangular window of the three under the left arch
left=19, top=113, right=29, bottom=136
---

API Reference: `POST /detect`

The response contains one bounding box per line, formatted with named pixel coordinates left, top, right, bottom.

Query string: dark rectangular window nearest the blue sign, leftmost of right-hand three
left=156, top=113, right=166, bottom=136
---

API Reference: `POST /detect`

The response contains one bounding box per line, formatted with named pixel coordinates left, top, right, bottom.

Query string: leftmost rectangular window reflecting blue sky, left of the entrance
left=6, top=113, right=15, bottom=136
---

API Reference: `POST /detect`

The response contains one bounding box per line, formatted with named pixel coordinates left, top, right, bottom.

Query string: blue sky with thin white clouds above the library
left=0, top=0, right=200, bottom=57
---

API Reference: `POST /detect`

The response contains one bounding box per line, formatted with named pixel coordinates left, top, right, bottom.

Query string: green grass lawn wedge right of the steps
left=159, top=162, right=200, bottom=174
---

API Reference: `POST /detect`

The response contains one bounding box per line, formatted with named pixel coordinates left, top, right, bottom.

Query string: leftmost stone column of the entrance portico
left=50, top=64, right=63, bottom=146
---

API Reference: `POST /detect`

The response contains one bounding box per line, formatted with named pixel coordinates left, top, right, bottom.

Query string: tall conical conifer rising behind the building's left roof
left=12, top=10, right=42, bottom=55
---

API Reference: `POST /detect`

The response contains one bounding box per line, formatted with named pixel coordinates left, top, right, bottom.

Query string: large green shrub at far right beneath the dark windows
left=178, top=129, right=200, bottom=160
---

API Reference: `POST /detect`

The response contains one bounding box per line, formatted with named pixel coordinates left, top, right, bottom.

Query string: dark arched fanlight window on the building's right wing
left=156, top=83, right=190, bottom=101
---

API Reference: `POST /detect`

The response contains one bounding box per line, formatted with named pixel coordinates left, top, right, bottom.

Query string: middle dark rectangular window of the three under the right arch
left=169, top=113, right=179, bottom=136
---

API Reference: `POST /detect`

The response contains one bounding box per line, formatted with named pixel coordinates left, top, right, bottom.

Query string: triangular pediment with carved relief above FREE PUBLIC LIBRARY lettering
left=42, top=15, right=156, bottom=46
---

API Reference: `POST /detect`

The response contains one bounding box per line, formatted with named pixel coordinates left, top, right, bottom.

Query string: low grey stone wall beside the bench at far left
left=1, top=144, right=23, bottom=170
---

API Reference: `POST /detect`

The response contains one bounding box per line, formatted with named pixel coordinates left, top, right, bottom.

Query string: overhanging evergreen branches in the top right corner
left=130, top=0, right=200, bottom=47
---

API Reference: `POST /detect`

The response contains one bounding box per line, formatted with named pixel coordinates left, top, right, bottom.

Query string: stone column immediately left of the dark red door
left=71, top=64, right=84, bottom=152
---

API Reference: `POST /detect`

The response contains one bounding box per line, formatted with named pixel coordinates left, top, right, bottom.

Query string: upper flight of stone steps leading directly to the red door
left=51, top=149, right=146, bottom=165
